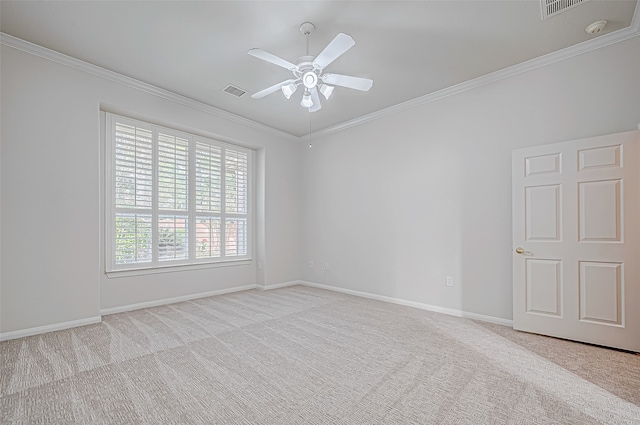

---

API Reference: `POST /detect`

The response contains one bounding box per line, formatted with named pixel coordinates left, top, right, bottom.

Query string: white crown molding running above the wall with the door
left=308, top=6, right=640, bottom=142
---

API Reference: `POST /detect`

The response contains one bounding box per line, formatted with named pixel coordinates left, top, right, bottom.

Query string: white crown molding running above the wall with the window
left=0, top=32, right=298, bottom=141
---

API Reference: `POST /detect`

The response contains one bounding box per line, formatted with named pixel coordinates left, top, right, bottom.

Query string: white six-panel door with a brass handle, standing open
left=512, top=131, right=640, bottom=352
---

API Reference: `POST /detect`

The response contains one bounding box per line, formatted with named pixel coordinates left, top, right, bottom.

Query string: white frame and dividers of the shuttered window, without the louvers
left=104, top=112, right=255, bottom=277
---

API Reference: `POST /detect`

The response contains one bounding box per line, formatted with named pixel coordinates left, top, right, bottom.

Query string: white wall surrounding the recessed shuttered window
left=0, top=45, right=301, bottom=333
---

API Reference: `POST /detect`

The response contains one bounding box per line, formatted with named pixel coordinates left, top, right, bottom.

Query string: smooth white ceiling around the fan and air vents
left=0, top=0, right=637, bottom=136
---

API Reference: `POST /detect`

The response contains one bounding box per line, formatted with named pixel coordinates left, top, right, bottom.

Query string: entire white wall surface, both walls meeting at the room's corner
left=0, top=37, right=640, bottom=333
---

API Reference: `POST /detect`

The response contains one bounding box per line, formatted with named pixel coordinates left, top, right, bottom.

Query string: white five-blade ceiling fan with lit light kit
left=248, top=22, right=373, bottom=112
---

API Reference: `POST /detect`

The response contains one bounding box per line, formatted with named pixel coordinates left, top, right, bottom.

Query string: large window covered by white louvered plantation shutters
left=106, top=113, right=252, bottom=272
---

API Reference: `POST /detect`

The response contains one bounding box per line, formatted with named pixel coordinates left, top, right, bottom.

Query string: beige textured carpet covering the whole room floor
left=0, top=286, right=640, bottom=425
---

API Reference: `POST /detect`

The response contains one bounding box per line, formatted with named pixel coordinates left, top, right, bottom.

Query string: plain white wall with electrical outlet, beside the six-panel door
left=300, top=37, right=640, bottom=319
